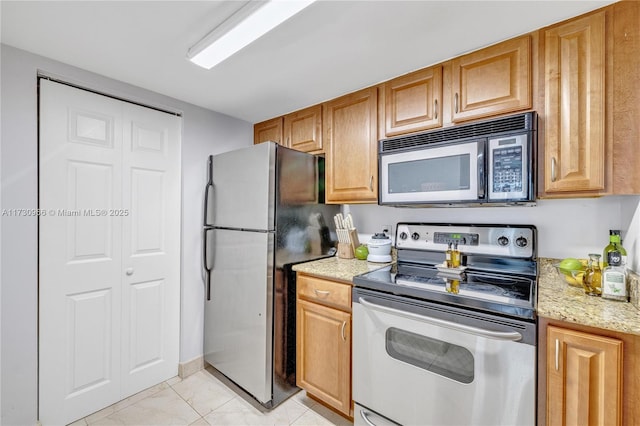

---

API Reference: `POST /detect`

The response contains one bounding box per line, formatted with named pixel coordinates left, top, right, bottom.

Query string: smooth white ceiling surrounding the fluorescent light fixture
left=0, top=0, right=612, bottom=123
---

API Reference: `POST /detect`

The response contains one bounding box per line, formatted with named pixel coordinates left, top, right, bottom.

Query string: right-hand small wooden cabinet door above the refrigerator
left=284, top=105, right=322, bottom=153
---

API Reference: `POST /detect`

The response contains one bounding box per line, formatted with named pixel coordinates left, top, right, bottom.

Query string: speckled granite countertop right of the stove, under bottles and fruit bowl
left=538, top=259, right=640, bottom=335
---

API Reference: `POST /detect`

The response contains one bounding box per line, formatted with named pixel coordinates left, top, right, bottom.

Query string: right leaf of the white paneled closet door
left=122, top=104, right=180, bottom=395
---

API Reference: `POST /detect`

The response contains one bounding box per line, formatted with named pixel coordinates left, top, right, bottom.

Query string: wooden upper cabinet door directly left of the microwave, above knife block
left=322, top=87, right=378, bottom=203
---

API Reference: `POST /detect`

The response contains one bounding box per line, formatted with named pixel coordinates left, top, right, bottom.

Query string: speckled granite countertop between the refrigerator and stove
left=293, top=256, right=391, bottom=282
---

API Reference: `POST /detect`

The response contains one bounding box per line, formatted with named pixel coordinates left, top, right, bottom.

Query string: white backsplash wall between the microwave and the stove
left=345, top=196, right=640, bottom=262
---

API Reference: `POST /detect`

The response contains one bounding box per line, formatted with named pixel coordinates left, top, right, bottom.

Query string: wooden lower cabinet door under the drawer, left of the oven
left=296, top=299, right=351, bottom=415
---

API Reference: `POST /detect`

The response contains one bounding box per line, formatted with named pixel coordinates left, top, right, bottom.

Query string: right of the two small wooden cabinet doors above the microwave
left=451, top=35, right=531, bottom=123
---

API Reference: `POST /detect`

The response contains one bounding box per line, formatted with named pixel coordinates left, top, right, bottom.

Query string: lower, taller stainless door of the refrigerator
left=204, top=229, right=274, bottom=403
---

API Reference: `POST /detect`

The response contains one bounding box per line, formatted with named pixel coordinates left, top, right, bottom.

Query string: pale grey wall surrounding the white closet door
left=0, top=45, right=253, bottom=425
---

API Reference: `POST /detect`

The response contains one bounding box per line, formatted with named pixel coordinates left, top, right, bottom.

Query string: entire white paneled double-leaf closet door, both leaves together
left=39, top=80, right=180, bottom=425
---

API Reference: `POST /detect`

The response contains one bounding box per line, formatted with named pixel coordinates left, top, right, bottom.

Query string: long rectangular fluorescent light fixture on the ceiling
left=187, top=0, right=315, bottom=69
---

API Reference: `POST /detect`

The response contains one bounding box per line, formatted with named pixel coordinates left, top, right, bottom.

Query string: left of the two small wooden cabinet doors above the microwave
left=384, top=66, right=442, bottom=137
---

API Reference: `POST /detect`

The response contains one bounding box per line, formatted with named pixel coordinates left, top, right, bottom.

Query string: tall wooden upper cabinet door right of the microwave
left=544, top=12, right=605, bottom=193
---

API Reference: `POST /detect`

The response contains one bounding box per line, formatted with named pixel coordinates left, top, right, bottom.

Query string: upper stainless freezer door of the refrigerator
left=208, top=142, right=276, bottom=231
